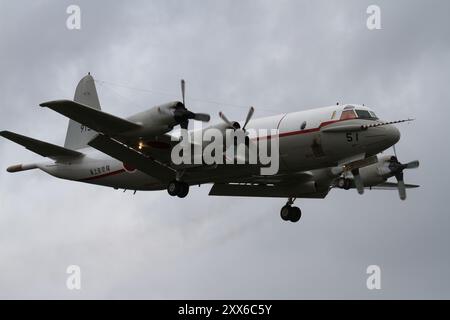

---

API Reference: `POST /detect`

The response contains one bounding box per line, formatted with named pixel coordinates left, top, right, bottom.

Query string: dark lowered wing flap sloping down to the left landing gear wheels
left=89, top=134, right=176, bottom=181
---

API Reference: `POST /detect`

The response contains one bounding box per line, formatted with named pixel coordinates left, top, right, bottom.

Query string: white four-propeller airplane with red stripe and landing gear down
left=0, top=73, right=419, bottom=222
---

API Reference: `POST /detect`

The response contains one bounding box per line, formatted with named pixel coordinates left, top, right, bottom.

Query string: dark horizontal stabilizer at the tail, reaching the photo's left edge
left=0, top=131, right=83, bottom=160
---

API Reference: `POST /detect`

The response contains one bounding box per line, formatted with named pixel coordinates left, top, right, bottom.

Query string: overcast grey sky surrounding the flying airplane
left=0, top=0, right=450, bottom=299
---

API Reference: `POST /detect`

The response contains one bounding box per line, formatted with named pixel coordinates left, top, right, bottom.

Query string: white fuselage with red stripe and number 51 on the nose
left=38, top=105, right=399, bottom=190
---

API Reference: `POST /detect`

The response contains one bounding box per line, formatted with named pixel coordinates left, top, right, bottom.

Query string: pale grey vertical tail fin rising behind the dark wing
left=64, top=73, right=101, bottom=150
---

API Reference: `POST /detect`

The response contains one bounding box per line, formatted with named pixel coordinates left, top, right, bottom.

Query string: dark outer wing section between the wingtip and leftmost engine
left=40, top=100, right=141, bottom=136
